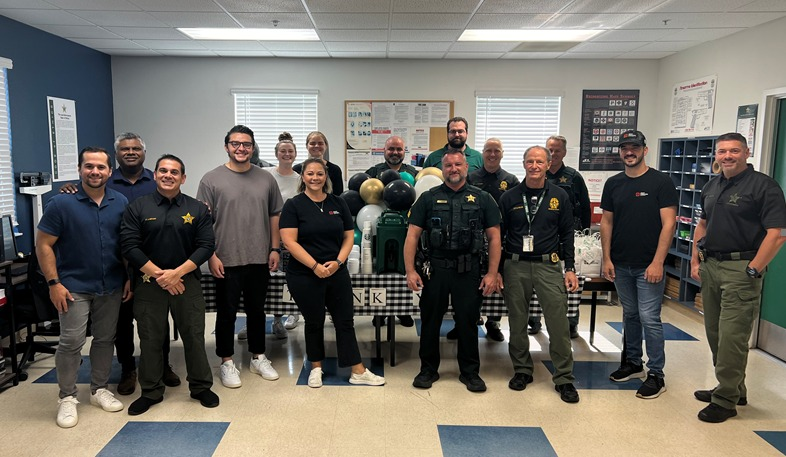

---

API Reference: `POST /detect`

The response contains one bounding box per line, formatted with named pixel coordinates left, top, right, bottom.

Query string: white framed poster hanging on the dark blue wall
left=46, top=97, right=79, bottom=181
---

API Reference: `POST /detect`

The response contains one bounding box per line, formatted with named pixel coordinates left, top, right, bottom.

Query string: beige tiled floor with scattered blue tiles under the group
left=0, top=303, right=786, bottom=457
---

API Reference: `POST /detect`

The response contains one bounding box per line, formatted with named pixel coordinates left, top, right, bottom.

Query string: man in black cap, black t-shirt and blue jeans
left=600, top=130, right=679, bottom=398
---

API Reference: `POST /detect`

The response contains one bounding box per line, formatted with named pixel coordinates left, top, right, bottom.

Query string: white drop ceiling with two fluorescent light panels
left=0, top=0, right=786, bottom=59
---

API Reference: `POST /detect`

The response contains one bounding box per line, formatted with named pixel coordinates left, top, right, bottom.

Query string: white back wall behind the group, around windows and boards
left=112, top=57, right=660, bottom=195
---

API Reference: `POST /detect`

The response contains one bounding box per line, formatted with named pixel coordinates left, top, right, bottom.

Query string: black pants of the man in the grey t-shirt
left=216, top=264, right=270, bottom=357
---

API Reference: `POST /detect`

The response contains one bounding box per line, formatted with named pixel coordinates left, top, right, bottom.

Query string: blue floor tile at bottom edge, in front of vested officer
left=437, top=425, right=557, bottom=457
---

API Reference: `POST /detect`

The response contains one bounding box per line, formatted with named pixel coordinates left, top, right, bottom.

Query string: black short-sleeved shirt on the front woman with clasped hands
left=278, top=193, right=355, bottom=273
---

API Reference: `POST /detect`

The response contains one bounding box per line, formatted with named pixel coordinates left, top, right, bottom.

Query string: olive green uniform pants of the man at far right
left=699, top=259, right=762, bottom=409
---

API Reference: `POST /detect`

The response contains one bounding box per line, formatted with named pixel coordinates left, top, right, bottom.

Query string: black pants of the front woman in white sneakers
left=287, top=268, right=360, bottom=367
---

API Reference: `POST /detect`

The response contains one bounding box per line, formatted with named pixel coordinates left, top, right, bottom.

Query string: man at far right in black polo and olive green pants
left=691, top=133, right=786, bottom=423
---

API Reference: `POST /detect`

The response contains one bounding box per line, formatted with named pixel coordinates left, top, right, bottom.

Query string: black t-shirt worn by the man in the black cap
left=600, top=168, right=679, bottom=268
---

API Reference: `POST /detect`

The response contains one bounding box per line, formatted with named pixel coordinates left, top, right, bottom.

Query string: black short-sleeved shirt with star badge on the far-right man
left=701, top=164, right=786, bottom=253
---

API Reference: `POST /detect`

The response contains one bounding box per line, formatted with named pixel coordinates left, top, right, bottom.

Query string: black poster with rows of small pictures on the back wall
left=579, top=90, right=639, bottom=170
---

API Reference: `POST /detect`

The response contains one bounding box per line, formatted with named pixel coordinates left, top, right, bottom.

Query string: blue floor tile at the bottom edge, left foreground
left=98, top=422, right=229, bottom=457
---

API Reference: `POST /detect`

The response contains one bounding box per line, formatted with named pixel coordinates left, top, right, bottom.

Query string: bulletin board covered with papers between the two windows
left=344, top=100, right=455, bottom=177
